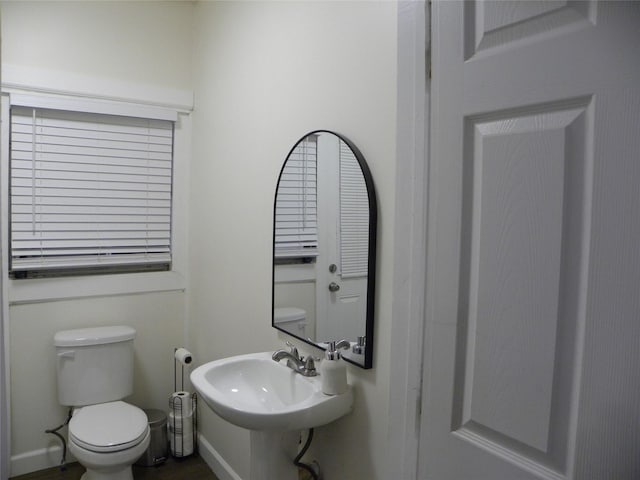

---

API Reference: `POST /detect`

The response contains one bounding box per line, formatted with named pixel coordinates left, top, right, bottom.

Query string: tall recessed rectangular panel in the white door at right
left=453, top=99, right=589, bottom=465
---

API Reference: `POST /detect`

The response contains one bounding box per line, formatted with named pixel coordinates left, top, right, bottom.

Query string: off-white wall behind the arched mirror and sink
left=188, top=2, right=397, bottom=480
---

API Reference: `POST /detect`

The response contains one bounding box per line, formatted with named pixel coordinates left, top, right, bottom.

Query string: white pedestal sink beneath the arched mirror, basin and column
left=191, top=352, right=353, bottom=480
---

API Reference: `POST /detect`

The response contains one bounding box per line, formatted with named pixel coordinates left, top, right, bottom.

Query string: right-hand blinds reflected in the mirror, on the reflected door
left=340, top=140, right=369, bottom=278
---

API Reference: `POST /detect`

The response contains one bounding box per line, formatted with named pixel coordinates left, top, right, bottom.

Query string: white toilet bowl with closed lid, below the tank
left=69, top=401, right=151, bottom=480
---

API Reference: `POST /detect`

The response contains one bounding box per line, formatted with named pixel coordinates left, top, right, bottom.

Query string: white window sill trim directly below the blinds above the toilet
left=7, top=271, right=186, bottom=305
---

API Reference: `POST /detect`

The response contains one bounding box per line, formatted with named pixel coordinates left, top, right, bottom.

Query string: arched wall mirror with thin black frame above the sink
left=272, top=130, right=377, bottom=368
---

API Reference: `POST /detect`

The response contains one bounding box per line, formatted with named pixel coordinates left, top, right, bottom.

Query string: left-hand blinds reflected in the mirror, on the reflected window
left=275, top=136, right=318, bottom=258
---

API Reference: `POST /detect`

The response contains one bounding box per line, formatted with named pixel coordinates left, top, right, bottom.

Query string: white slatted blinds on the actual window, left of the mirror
left=10, top=106, right=173, bottom=277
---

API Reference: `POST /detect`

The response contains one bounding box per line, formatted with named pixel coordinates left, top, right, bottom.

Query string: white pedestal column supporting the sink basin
left=249, top=430, right=300, bottom=480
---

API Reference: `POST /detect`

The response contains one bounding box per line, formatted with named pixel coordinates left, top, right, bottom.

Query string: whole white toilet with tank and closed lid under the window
left=54, top=326, right=151, bottom=480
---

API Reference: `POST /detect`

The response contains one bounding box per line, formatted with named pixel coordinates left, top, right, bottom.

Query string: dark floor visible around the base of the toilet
left=10, top=455, right=219, bottom=480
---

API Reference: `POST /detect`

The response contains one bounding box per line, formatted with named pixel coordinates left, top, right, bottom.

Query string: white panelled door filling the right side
left=418, top=1, right=640, bottom=480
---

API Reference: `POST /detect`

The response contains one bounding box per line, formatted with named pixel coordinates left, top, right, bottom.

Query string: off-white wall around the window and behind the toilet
left=0, top=1, right=193, bottom=475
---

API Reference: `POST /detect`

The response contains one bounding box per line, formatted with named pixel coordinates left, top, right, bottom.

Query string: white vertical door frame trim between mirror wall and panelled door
left=386, top=0, right=431, bottom=480
